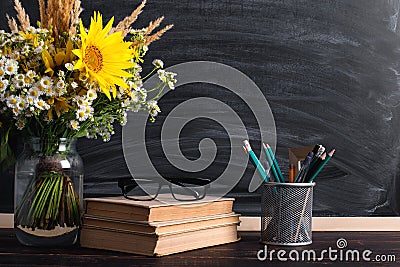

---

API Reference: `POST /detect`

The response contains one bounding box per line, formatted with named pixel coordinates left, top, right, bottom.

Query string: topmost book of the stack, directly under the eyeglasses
left=85, top=196, right=234, bottom=222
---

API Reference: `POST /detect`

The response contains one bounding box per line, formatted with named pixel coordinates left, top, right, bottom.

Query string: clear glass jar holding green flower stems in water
left=14, top=137, right=83, bottom=246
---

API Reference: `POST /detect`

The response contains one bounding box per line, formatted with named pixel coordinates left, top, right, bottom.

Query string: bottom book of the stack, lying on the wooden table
left=80, top=223, right=239, bottom=256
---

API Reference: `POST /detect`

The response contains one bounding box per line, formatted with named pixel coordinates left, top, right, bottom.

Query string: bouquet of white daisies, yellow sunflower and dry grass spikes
left=0, top=0, right=176, bottom=234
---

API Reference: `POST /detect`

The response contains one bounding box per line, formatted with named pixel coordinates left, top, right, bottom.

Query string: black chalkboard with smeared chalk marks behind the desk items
left=0, top=0, right=400, bottom=216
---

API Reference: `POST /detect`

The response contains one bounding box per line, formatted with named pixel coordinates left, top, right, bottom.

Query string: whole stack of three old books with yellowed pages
left=80, top=197, right=240, bottom=256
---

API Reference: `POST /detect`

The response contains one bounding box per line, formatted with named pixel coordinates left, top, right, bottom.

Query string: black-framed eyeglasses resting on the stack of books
left=118, top=178, right=211, bottom=201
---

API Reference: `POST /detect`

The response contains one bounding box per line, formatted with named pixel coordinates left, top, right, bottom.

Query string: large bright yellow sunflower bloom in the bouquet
left=72, top=12, right=135, bottom=99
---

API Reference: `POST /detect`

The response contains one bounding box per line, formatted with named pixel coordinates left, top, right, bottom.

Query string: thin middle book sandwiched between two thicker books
left=83, top=212, right=240, bottom=235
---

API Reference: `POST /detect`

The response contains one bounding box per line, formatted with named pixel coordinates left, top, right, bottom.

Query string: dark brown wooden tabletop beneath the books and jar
left=0, top=229, right=400, bottom=267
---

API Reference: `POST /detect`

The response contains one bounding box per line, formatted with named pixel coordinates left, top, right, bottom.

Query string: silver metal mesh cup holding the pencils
left=261, top=182, right=315, bottom=246
